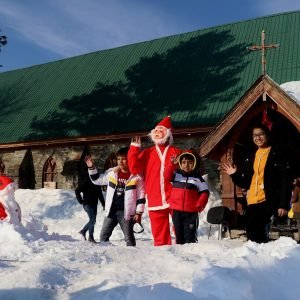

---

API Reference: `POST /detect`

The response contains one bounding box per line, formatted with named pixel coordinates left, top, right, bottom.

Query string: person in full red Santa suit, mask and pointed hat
left=128, top=116, right=181, bottom=246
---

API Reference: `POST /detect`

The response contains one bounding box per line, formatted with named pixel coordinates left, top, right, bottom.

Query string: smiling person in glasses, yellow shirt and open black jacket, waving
left=221, top=124, right=292, bottom=243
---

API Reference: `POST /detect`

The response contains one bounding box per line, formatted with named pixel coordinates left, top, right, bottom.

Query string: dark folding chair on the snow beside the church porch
left=207, top=206, right=230, bottom=240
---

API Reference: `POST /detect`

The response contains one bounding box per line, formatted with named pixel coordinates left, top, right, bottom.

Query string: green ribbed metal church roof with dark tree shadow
left=0, top=11, right=300, bottom=144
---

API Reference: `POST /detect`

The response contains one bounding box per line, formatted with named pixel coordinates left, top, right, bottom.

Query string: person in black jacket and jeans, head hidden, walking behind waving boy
left=75, top=177, right=104, bottom=243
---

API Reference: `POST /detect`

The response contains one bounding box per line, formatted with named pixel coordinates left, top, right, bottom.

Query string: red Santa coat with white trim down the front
left=127, top=145, right=181, bottom=210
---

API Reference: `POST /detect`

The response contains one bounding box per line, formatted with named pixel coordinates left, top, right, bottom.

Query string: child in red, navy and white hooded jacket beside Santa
left=170, top=152, right=209, bottom=244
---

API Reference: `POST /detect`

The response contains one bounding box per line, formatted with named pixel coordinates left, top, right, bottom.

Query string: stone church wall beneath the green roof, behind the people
left=0, top=137, right=220, bottom=189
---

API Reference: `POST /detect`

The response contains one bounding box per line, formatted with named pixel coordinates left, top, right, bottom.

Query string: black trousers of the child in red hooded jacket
left=172, top=210, right=199, bottom=244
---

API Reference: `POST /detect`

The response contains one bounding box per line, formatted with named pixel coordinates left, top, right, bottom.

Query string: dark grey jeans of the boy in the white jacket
left=100, top=210, right=136, bottom=246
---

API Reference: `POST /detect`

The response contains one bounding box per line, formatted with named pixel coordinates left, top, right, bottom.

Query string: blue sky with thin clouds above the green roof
left=0, top=0, right=300, bottom=72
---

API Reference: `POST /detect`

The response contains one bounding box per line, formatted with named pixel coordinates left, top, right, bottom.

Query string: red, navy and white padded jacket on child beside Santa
left=170, top=170, right=209, bottom=212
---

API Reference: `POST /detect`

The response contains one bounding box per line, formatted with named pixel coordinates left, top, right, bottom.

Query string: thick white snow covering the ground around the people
left=0, top=176, right=300, bottom=300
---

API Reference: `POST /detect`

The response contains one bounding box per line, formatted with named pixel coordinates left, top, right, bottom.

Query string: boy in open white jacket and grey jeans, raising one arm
left=85, top=147, right=146, bottom=246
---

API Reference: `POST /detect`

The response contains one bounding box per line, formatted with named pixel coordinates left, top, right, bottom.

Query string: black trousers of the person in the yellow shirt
left=246, top=201, right=272, bottom=243
